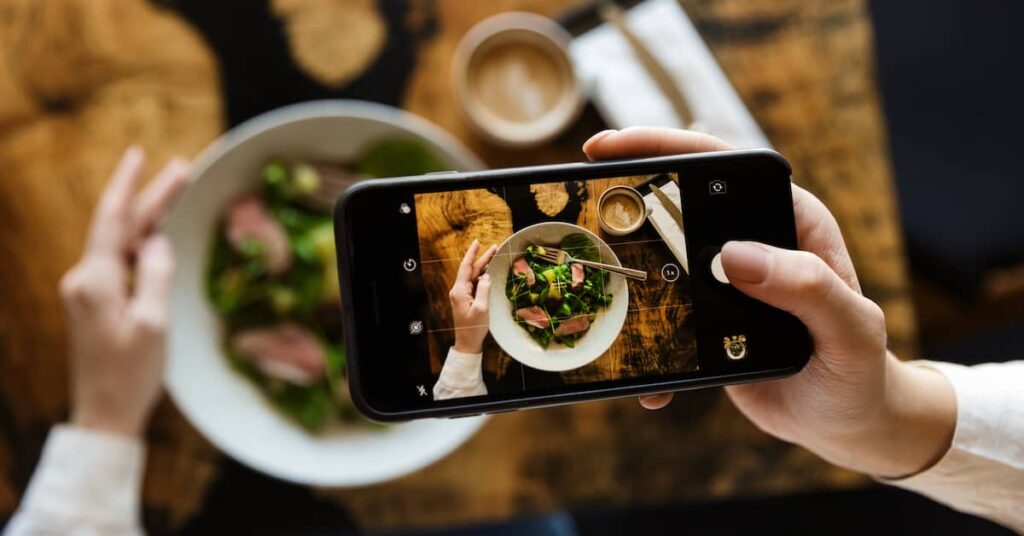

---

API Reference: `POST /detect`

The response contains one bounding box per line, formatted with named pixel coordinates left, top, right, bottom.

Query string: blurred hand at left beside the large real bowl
left=60, top=148, right=189, bottom=436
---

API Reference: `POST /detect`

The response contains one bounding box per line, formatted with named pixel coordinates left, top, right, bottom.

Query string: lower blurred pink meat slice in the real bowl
left=230, top=323, right=326, bottom=385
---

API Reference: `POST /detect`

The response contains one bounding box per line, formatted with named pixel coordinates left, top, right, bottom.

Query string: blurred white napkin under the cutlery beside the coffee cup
left=569, top=0, right=770, bottom=148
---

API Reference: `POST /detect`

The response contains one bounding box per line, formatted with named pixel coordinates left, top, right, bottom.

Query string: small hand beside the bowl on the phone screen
left=449, top=240, right=498, bottom=354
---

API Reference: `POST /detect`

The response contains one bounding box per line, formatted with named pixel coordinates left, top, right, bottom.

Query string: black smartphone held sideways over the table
left=334, top=150, right=811, bottom=421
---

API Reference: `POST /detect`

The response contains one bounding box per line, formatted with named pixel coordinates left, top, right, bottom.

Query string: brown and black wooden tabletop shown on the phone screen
left=416, top=176, right=697, bottom=385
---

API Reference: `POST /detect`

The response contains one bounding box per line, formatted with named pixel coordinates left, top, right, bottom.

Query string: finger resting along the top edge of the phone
left=583, top=127, right=732, bottom=160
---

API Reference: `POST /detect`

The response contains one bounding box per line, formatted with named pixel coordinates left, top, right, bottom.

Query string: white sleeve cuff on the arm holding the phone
left=882, top=361, right=1024, bottom=532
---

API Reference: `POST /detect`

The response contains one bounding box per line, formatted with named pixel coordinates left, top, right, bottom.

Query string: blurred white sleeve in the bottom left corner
left=4, top=425, right=145, bottom=536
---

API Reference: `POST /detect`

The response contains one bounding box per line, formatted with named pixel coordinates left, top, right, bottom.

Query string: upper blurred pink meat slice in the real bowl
left=226, top=196, right=292, bottom=276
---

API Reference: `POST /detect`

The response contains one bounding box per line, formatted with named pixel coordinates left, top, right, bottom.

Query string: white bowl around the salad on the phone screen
left=487, top=221, right=630, bottom=372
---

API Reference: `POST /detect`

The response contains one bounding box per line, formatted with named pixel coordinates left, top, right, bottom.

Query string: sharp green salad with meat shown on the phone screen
left=505, top=233, right=611, bottom=348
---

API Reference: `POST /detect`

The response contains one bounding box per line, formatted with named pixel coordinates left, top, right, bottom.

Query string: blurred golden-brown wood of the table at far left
left=0, top=0, right=222, bottom=519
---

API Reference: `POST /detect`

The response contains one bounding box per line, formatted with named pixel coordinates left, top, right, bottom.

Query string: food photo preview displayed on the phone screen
left=404, top=173, right=700, bottom=401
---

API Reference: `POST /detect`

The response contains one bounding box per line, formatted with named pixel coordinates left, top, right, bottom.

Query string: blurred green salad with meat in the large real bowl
left=207, top=139, right=446, bottom=431
